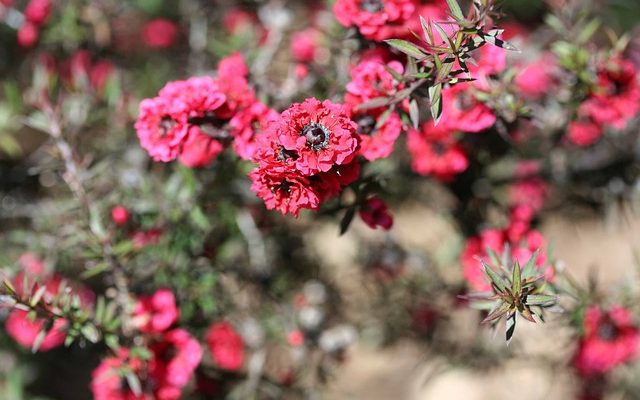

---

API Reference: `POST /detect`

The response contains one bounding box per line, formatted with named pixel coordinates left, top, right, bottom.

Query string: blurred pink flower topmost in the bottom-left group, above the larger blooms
left=134, top=289, right=179, bottom=333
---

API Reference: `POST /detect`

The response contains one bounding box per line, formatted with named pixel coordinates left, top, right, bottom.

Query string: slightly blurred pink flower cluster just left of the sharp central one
left=135, top=53, right=274, bottom=167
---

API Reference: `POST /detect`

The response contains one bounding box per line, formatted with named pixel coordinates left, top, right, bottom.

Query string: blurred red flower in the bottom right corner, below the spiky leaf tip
left=573, top=306, right=640, bottom=376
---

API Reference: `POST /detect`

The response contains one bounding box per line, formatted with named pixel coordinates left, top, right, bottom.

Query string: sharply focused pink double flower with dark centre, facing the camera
left=271, top=98, right=359, bottom=175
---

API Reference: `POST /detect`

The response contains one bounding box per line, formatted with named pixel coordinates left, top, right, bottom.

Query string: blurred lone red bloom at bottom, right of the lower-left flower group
left=205, top=322, right=244, bottom=371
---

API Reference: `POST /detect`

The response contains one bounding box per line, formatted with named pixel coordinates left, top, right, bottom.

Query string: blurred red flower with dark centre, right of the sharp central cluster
left=407, top=121, right=469, bottom=181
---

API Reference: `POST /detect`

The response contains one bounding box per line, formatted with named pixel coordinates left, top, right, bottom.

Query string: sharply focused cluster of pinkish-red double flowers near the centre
left=249, top=98, right=359, bottom=216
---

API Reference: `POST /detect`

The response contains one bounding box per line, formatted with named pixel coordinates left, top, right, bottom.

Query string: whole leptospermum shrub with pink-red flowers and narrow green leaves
left=0, top=0, right=640, bottom=400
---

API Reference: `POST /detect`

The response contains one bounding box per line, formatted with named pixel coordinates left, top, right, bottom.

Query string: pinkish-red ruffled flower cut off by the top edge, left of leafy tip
left=333, top=0, right=418, bottom=41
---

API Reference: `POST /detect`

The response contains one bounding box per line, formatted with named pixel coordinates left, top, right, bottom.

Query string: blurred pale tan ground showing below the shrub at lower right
left=313, top=207, right=640, bottom=400
